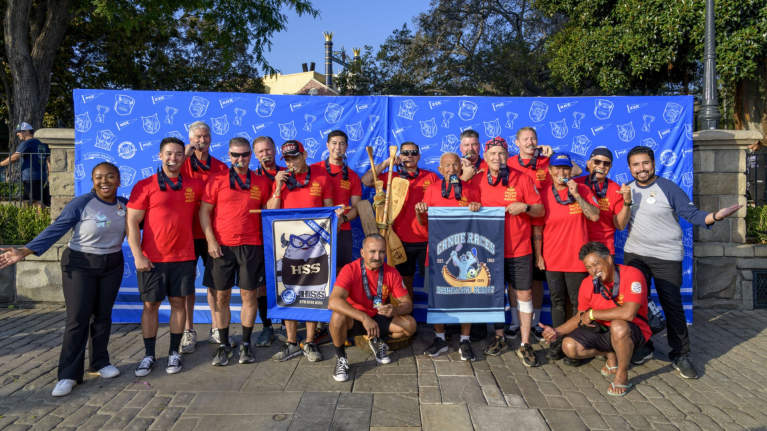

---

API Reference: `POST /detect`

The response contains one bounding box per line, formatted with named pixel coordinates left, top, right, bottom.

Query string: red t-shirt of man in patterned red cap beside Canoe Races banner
left=474, top=170, right=542, bottom=258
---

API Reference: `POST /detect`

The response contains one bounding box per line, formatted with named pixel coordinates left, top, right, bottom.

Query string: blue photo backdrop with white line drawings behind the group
left=74, top=90, right=693, bottom=323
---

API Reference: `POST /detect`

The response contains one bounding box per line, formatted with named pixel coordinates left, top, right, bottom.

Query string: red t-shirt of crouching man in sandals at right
left=578, top=265, right=652, bottom=341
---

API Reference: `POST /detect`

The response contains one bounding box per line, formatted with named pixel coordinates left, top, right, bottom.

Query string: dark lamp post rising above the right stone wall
left=698, top=0, right=722, bottom=130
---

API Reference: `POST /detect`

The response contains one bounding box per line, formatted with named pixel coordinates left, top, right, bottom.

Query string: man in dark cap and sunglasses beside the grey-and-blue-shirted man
left=573, top=147, right=631, bottom=259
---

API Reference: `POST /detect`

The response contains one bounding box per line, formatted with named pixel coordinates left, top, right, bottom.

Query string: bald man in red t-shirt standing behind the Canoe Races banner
left=415, top=153, right=482, bottom=361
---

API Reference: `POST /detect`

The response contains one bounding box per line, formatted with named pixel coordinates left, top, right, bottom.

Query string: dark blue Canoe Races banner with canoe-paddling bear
left=426, top=207, right=505, bottom=323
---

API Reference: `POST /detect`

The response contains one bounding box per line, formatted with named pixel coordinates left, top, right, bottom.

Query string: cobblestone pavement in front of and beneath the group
left=0, top=308, right=767, bottom=431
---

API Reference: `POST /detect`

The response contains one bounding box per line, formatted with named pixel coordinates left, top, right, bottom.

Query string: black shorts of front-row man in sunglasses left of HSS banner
left=202, top=245, right=266, bottom=290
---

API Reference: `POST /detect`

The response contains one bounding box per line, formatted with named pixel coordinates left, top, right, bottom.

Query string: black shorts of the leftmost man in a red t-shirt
left=136, top=260, right=197, bottom=302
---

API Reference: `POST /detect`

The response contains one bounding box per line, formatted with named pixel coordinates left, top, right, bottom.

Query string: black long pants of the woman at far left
left=58, top=248, right=124, bottom=383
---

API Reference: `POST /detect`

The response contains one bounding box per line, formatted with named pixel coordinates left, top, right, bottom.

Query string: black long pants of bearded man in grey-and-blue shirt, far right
left=623, top=253, right=690, bottom=359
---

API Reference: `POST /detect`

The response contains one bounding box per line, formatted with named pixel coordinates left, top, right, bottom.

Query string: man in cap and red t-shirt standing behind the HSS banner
left=266, top=140, right=344, bottom=362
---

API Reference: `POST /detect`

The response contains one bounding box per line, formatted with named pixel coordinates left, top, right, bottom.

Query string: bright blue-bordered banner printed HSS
left=261, top=207, right=338, bottom=322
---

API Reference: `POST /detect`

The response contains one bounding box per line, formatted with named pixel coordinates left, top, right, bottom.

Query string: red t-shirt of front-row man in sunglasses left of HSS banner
left=202, top=171, right=271, bottom=247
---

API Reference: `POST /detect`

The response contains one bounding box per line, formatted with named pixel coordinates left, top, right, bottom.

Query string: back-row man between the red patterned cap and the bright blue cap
left=506, top=127, right=582, bottom=341
